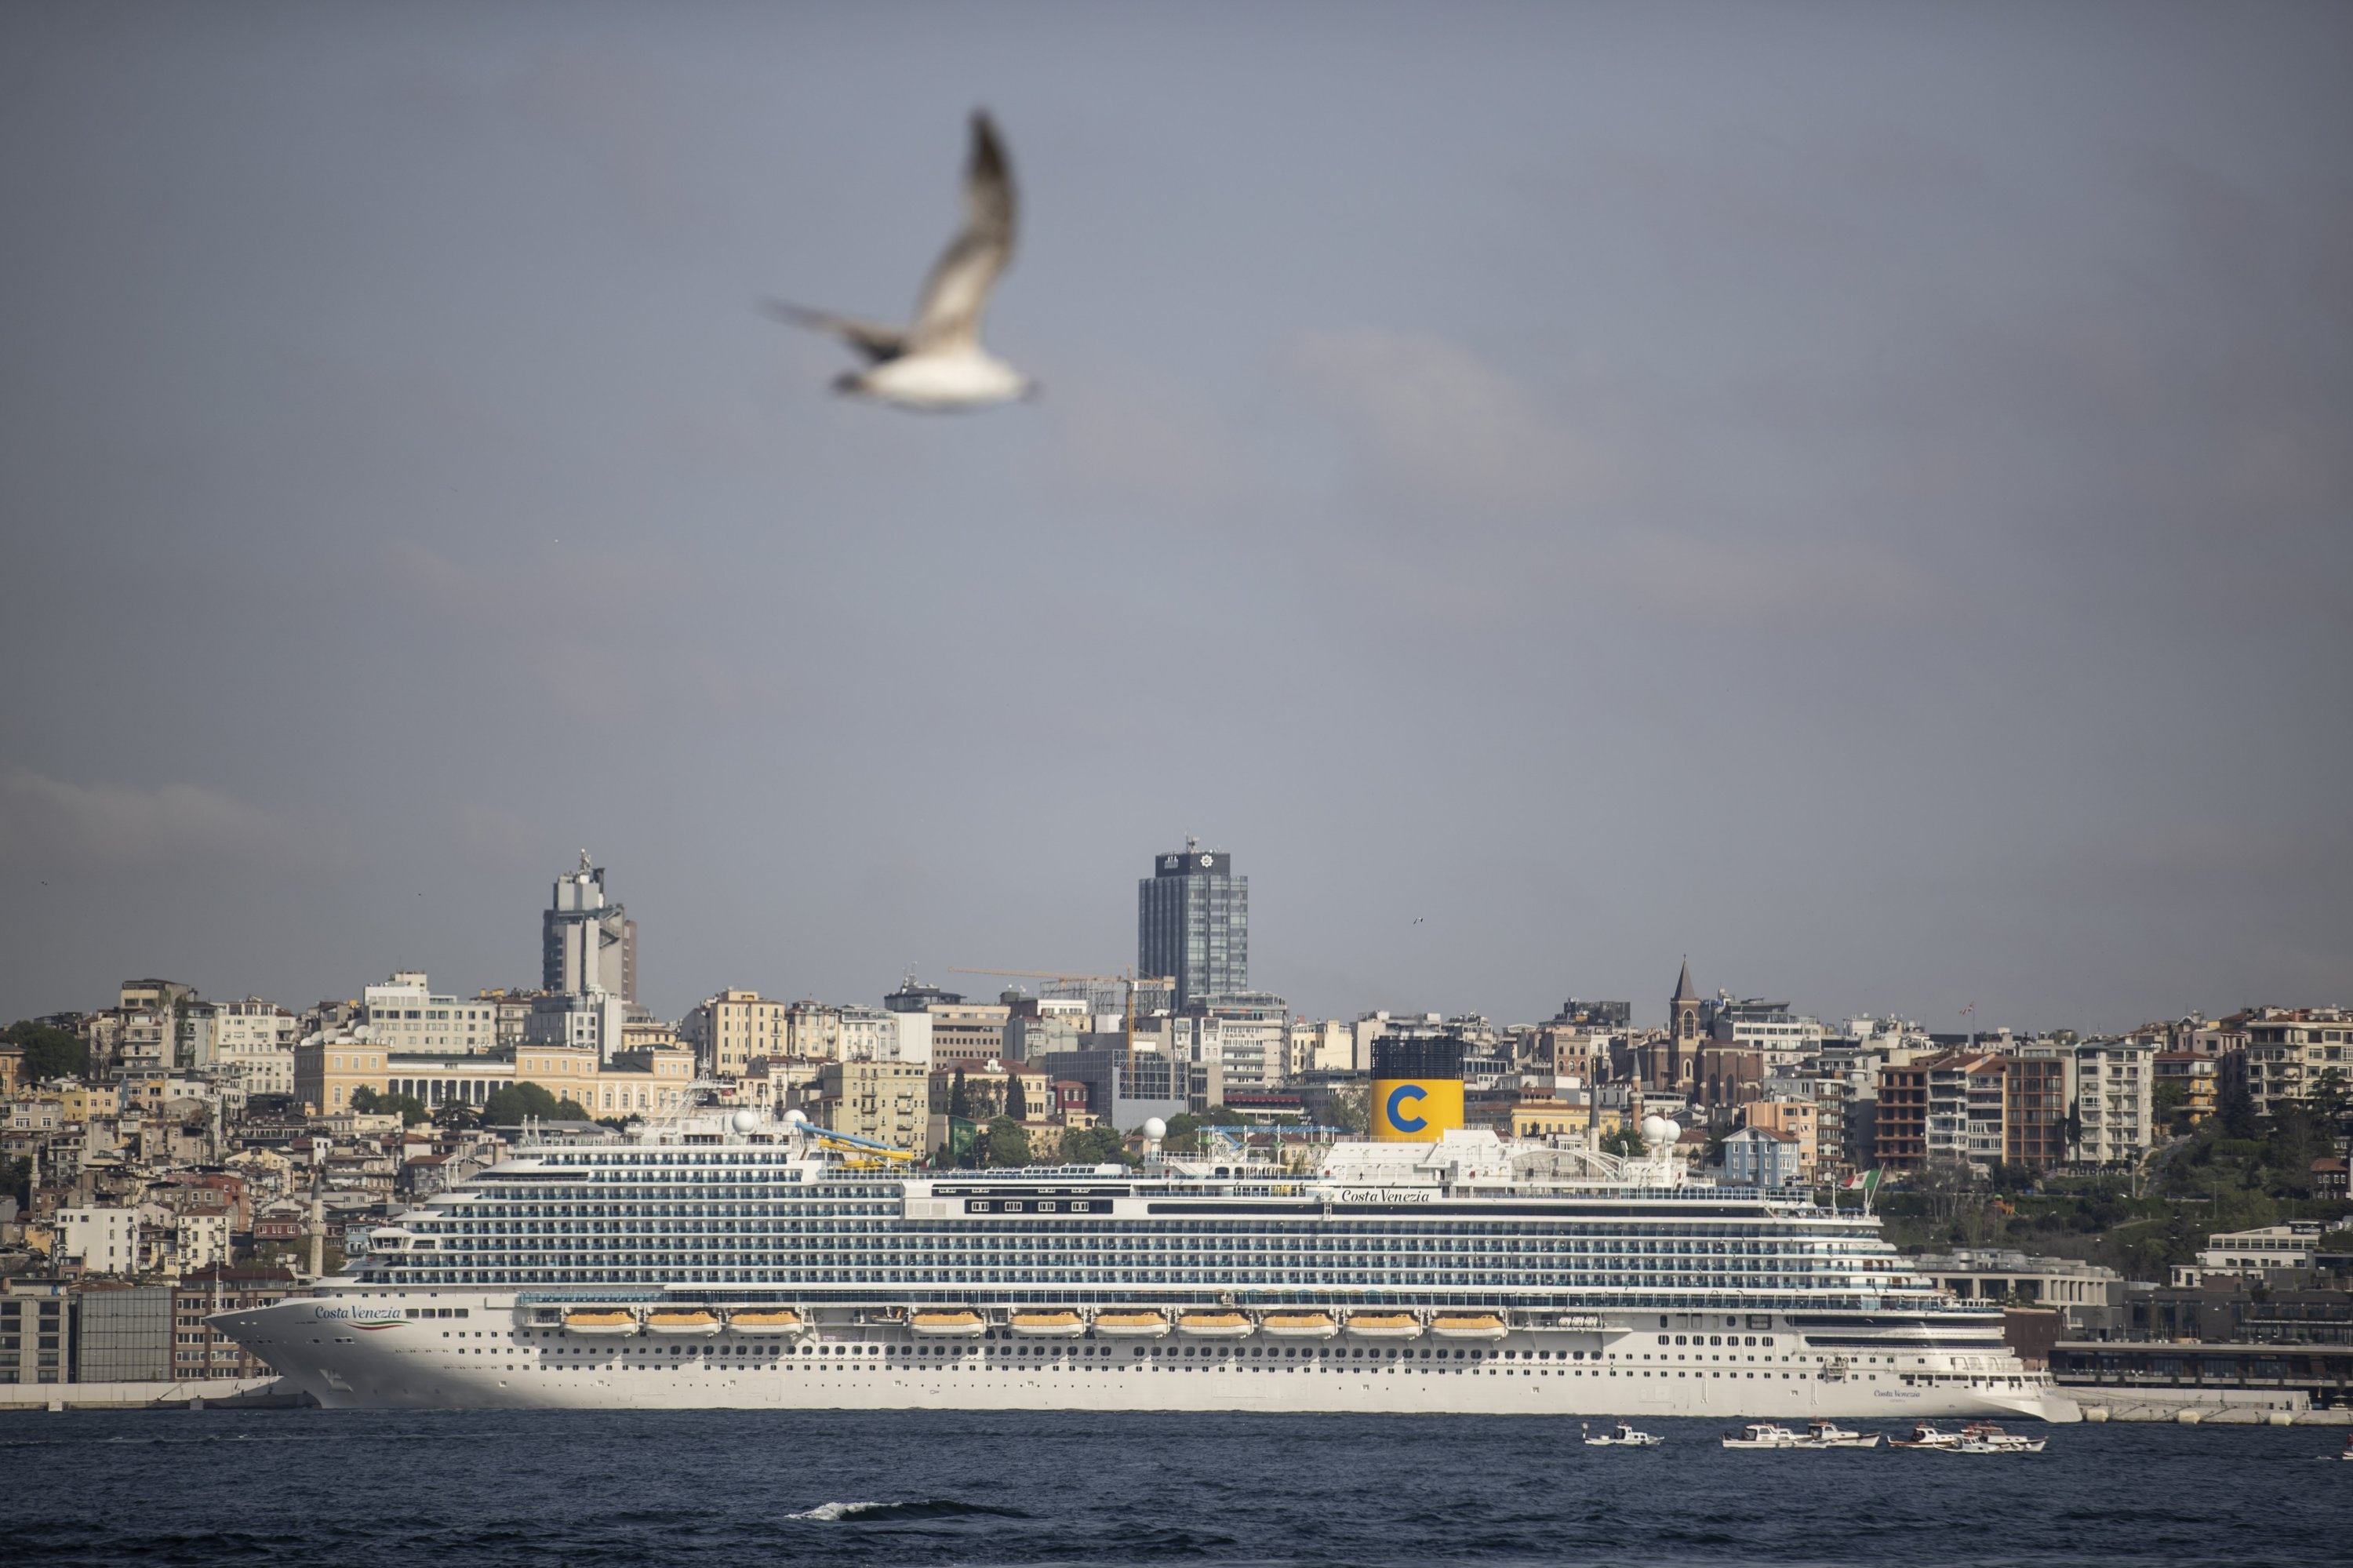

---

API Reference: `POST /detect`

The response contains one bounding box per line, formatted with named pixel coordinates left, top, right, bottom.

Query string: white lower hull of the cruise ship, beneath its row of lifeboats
left=219, top=1295, right=2080, bottom=1422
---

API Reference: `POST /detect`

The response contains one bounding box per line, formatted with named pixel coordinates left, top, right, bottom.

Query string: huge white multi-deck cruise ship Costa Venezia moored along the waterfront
left=214, top=1083, right=2078, bottom=1420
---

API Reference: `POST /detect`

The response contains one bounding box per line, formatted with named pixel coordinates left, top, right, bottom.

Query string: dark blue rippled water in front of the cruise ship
left=0, top=1410, right=2353, bottom=1568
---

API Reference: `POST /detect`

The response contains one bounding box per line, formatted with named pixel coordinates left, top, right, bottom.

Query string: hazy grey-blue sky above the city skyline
left=0, top=2, right=2353, bottom=1029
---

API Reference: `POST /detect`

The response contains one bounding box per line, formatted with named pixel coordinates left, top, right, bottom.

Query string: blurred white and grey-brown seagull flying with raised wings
left=767, top=108, right=1038, bottom=412
